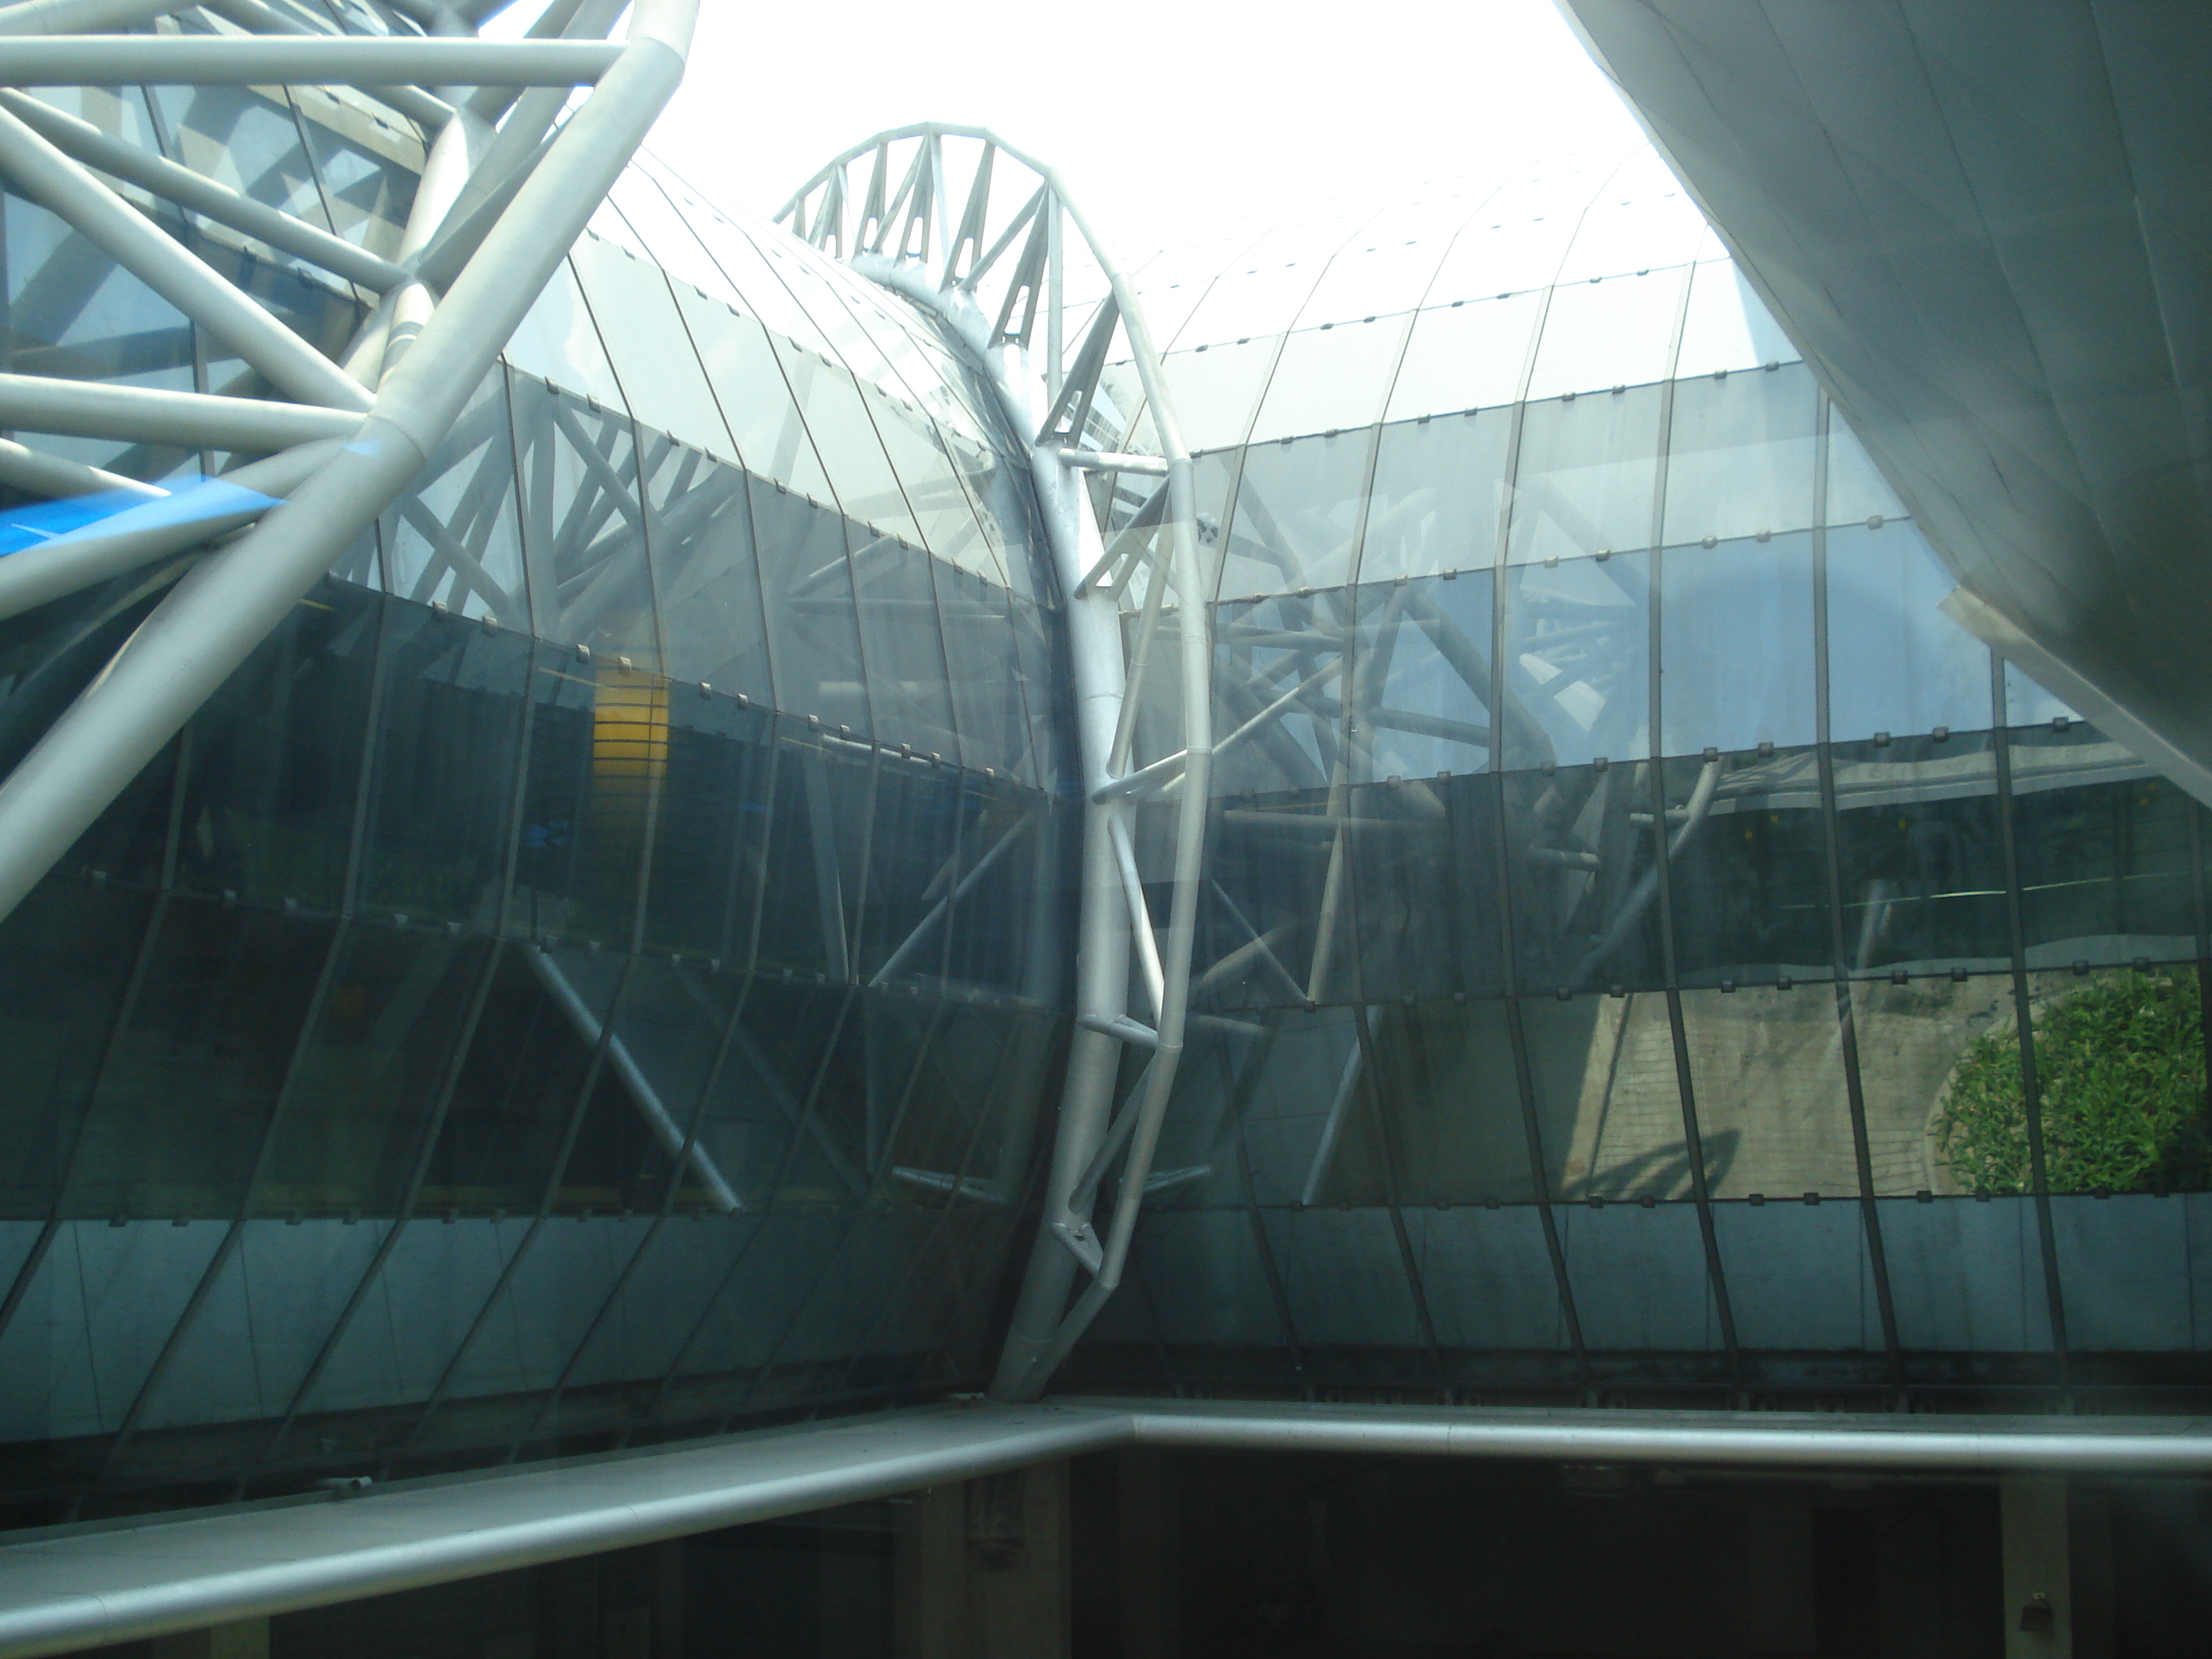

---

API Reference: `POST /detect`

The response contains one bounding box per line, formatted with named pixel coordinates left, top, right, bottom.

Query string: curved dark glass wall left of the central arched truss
left=0, top=81, right=1069, bottom=1524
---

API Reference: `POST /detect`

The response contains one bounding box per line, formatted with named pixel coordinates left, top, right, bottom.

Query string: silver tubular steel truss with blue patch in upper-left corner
left=0, top=0, right=699, bottom=916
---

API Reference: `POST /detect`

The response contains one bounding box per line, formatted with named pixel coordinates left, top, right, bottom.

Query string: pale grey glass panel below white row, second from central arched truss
left=1360, top=411, right=1513, bottom=582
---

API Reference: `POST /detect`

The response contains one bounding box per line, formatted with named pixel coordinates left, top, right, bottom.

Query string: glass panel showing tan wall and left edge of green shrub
left=1851, top=974, right=2024, bottom=1203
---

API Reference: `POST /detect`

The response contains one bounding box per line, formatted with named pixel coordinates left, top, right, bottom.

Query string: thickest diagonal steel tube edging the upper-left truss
left=0, top=0, right=697, bottom=916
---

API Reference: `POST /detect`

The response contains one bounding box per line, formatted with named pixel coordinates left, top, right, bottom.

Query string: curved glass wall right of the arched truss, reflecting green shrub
left=1069, top=153, right=2212, bottom=1405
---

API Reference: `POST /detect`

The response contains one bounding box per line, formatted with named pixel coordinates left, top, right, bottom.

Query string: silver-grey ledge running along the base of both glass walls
left=0, top=1401, right=2212, bottom=1659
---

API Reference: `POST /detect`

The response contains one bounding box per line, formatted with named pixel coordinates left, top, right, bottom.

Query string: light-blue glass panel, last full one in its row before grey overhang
left=1659, top=531, right=1818, bottom=755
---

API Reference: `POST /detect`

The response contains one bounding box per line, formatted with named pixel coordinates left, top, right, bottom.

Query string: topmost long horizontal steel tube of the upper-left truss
left=0, top=35, right=621, bottom=86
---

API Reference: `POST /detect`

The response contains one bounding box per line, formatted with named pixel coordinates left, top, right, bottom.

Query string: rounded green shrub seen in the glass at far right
left=1936, top=969, right=2212, bottom=1192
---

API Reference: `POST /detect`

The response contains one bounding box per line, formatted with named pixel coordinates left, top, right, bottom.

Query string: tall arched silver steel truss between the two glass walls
left=776, top=124, right=1212, bottom=1401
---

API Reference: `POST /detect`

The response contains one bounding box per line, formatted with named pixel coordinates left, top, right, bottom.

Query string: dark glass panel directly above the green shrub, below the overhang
left=2010, top=726, right=2196, bottom=969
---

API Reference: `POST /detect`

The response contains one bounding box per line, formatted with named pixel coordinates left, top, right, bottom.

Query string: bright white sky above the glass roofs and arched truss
left=502, top=0, right=1635, bottom=264
